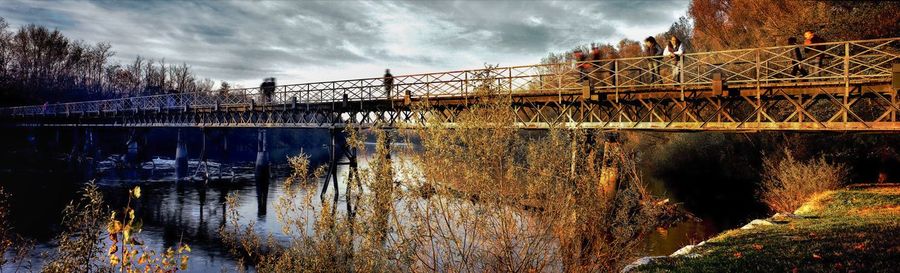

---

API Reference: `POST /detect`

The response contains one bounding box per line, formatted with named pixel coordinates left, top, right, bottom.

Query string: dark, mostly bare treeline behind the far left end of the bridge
left=0, top=17, right=228, bottom=106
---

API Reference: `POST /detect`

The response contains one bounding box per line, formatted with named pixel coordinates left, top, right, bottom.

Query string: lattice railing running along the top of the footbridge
left=0, top=38, right=900, bottom=115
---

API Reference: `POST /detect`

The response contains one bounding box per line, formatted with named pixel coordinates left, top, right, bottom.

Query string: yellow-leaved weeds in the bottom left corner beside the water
left=0, top=182, right=190, bottom=273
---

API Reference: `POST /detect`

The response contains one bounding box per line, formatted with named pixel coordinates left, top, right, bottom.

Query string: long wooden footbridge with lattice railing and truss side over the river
left=0, top=38, right=900, bottom=131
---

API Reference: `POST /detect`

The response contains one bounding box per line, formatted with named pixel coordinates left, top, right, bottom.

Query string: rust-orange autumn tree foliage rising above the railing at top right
left=688, top=0, right=900, bottom=50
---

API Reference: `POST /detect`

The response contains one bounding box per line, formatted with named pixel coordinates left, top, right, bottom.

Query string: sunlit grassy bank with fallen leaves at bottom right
left=636, top=185, right=900, bottom=272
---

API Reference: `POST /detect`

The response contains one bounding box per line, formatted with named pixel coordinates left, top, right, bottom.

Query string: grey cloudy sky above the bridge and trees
left=0, top=0, right=688, bottom=87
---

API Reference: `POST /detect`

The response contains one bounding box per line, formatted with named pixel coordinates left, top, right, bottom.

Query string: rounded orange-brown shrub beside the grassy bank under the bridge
left=761, top=149, right=849, bottom=212
